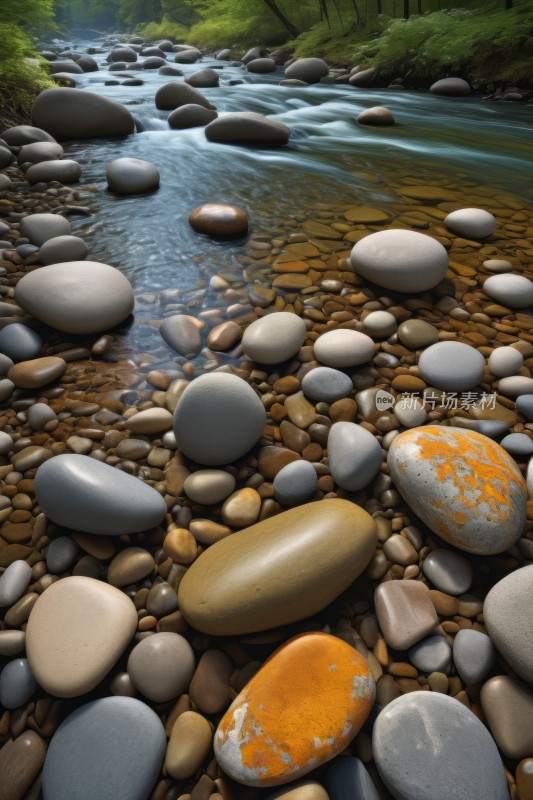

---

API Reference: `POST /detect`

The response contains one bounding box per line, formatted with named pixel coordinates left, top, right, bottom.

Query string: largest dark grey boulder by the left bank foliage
left=32, top=89, right=135, bottom=141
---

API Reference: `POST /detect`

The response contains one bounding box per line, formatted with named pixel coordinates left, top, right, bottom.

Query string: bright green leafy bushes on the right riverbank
left=353, top=3, right=533, bottom=82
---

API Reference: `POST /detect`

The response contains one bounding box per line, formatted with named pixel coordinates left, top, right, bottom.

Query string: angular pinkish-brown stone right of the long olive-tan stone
left=374, top=581, right=439, bottom=650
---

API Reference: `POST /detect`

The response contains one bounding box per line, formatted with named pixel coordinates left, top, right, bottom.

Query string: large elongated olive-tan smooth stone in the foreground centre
left=178, top=499, right=377, bottom=636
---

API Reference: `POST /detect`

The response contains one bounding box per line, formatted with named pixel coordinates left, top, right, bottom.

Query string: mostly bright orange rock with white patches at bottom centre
left=214, top=633, right=375, bottom=787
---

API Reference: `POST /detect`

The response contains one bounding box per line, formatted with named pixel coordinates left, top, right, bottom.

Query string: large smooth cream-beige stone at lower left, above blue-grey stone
left=26, top=576, right=137, bottom=697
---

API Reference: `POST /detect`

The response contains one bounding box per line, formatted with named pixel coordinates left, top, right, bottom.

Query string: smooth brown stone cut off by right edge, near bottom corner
left=480, top=675, right=533, bottom=759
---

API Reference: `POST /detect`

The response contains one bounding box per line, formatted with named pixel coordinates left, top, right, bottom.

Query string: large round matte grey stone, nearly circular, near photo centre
left=174, top=372, right=266, bottom=466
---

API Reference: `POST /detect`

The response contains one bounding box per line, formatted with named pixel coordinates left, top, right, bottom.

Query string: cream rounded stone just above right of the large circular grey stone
left=242, top=311, right=307, bottom=364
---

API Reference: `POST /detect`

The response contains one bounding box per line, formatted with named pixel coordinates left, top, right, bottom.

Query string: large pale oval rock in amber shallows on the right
left=350, top=230, right=448, bottom=292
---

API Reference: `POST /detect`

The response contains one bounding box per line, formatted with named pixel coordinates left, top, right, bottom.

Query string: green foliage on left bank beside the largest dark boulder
left=0, top=22, right=56, bottom=127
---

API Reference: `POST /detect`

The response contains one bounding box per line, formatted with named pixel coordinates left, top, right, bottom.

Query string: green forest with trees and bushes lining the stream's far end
left=0, top=0, right=533, bottom=123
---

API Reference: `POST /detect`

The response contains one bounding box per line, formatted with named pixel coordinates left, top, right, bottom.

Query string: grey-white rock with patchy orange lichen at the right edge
left=388, top=425, right=527, bottom=555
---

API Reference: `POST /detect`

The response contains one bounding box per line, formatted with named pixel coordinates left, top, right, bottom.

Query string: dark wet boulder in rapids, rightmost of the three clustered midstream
left=205, top=111, right=290, bottom=145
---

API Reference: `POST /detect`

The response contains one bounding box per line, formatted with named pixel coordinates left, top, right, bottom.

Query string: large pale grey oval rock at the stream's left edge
left=15, top=262, right=134, bottom=334
